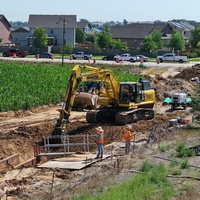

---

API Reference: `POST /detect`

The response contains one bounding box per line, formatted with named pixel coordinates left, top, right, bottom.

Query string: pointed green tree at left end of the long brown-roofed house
left=97, top=25, right=113, bottom=49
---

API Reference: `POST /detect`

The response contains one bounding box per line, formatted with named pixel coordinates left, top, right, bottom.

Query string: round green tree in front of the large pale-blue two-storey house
left=32, top=27, right=48, bottom=52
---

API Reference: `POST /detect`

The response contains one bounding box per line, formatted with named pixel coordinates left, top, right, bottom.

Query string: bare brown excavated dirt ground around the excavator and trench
left=0, top=64, right=200, bottom=200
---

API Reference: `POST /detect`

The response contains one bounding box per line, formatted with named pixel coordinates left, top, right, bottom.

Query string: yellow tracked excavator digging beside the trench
left=52, top=65, right=155, bottom=135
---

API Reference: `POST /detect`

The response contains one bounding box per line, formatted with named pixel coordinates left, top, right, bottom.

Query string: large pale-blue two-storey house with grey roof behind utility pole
left=28, top=15, right=77, bottom=47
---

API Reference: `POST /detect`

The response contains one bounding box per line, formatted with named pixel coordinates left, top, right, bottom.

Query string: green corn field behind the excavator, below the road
left=0, top=62, right=144, bottom=112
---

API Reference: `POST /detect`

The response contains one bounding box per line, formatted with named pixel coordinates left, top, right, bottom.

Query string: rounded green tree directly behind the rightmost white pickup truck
left=168, top=29, right=185, bottom=51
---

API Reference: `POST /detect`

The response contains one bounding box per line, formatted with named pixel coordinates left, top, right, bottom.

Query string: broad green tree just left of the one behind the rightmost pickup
left=139, top=30, right=163, bottom=55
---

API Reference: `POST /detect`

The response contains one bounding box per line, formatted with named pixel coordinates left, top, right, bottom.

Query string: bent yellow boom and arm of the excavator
left=53, top=65, right=120, bottom=135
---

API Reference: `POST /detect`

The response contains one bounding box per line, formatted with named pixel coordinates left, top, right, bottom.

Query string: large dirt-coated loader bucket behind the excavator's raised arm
left=73, top=92, right=98, bottom=109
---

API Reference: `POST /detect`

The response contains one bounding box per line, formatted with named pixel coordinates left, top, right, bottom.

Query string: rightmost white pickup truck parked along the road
left=157, top=53, right=187, bottom=63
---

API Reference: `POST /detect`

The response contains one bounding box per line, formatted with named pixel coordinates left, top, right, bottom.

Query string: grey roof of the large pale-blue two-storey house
left=28, top=14, right=76, bottom=28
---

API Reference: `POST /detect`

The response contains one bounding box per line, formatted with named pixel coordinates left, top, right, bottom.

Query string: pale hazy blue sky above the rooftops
left=0, top=0, right=200, bottom=22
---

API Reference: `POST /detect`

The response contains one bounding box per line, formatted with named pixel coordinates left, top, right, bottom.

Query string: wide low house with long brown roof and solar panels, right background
left=111, top=22, right=195, bottom=50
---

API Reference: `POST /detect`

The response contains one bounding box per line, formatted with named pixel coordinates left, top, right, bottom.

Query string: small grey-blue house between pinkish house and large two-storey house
left=11, top=26, right=29, bottom=46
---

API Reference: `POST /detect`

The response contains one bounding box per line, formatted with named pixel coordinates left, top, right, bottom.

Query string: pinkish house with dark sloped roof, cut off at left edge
left=0, top=14, right=12, bottom=45
